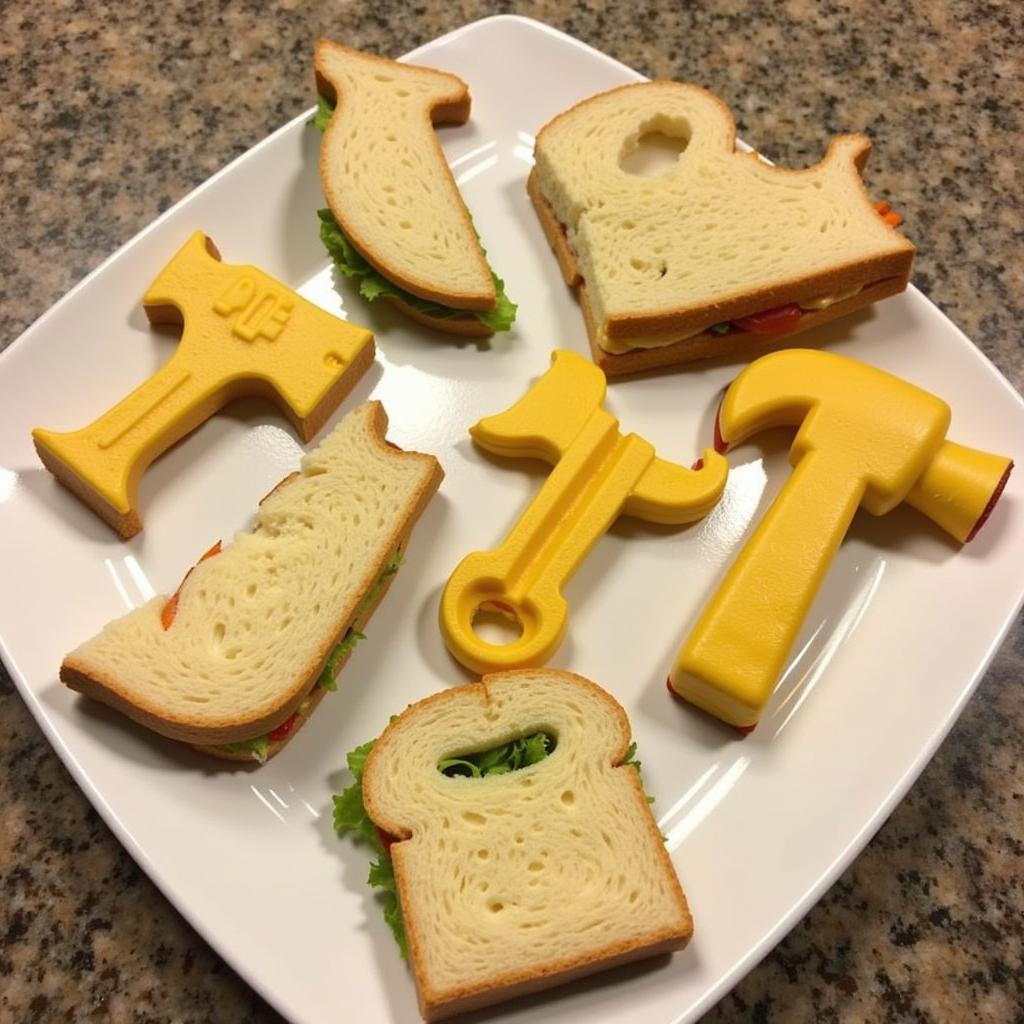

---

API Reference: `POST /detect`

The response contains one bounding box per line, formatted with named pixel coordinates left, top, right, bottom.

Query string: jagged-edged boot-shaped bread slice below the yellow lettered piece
left=60, top=401, right=443, bottom=746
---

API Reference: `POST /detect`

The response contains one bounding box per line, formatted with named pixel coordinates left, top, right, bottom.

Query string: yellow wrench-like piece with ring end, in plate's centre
left=440, top=349, right=728, bottom=673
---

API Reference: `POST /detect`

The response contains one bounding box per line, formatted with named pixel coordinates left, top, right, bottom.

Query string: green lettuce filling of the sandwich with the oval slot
left=334, top=732, right=654, bottom=959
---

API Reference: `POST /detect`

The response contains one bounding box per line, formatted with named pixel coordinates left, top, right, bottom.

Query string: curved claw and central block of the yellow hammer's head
left=718, top=349, right=949, bottom=515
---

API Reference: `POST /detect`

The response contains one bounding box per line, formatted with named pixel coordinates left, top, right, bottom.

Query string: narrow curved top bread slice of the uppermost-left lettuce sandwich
left=315, top=39, right=498, bottom=315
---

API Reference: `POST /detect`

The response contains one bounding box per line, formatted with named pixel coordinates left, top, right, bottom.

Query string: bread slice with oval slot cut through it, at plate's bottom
left=362, top=669, right=693, bottom=1021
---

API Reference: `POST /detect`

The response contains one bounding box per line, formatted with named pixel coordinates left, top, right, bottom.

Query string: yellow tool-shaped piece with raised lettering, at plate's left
left=32, top=231, right=374, bottom=538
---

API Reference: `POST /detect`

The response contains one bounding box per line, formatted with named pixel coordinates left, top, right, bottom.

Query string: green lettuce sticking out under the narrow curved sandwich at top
left=309, top=96, right=517, bottom=331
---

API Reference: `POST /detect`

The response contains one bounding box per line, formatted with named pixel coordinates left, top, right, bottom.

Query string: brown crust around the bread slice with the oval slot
left=364, top=669, right=693, bottom=1021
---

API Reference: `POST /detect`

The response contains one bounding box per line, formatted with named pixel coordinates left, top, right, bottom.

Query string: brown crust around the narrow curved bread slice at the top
left=314, top=39, right=498, bottom=311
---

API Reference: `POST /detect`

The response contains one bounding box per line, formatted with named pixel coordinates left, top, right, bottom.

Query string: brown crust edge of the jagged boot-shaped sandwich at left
left=59, top=401, right=444, bottom=746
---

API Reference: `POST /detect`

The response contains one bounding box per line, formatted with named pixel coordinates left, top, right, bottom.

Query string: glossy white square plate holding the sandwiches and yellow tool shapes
left=0, top=17, right=1024, bottom=1024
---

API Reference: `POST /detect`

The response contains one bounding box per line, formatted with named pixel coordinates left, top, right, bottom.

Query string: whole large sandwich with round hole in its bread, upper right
left=527, top=82, right=913, bottom=376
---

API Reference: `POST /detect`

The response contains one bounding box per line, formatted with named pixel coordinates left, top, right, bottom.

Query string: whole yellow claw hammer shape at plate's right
left=669, top=349, right=1013, bottom=729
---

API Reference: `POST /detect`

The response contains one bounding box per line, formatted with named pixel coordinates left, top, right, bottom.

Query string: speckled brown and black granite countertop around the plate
left=0, top=0, right=1024, bottom=1024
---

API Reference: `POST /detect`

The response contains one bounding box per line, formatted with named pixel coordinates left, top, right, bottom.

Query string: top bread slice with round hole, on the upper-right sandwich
left=536, top=82, right=912, bottom=351
